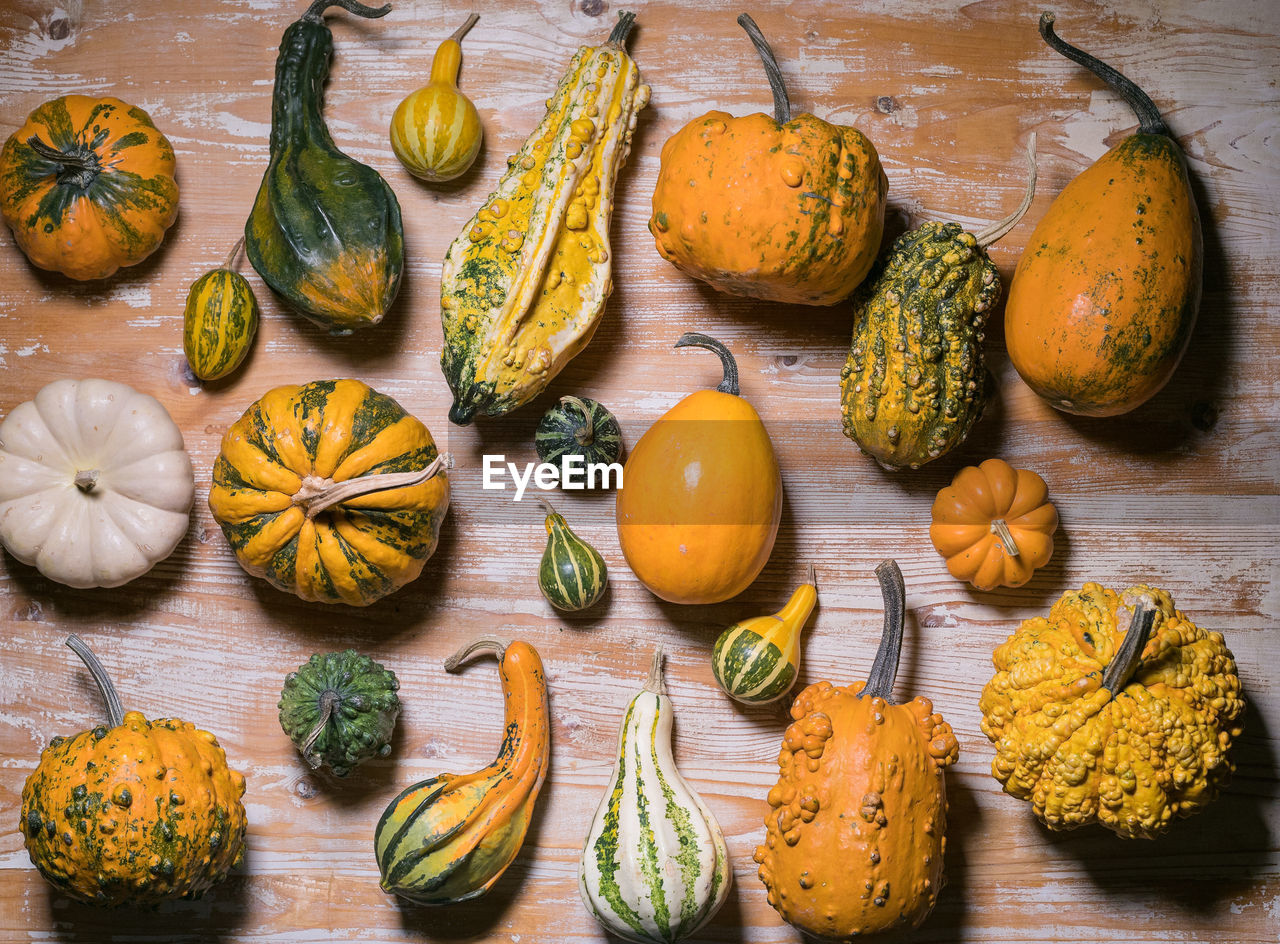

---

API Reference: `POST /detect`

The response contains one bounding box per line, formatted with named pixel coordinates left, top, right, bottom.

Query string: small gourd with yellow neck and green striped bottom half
left=712, top=564, right=818, bottom=705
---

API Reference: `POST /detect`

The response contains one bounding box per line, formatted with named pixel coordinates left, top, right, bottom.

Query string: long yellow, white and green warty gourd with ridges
left=440, top=13, right=649, bottom=426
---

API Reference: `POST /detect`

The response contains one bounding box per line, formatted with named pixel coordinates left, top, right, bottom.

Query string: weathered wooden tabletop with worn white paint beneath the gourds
left=0, top=0, right=1280, bottom=944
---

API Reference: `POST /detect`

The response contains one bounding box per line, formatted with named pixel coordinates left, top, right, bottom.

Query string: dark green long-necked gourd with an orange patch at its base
left=244, top=0, right=404, bottom=334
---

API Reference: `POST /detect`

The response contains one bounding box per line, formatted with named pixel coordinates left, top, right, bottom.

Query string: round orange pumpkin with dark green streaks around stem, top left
left=0, top=95, right=178, bottom=280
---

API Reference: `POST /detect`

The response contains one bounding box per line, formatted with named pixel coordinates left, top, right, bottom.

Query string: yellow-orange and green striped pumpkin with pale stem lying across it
left=209, top=380, right=449, bottom=606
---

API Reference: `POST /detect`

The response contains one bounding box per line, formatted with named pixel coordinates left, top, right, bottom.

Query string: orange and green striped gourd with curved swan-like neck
left=374, top=637, right=550, bottom=904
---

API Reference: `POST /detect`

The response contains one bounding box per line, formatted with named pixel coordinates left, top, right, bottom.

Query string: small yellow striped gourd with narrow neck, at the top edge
left=390, top=13, right=484, bottom=182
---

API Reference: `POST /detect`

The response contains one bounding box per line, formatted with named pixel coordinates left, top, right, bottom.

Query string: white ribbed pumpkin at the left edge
left=0, top=380, right=196, bottom=587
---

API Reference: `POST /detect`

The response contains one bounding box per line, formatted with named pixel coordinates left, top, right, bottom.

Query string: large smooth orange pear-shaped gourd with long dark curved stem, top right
left=1005, top=13, right=1203, bottom=416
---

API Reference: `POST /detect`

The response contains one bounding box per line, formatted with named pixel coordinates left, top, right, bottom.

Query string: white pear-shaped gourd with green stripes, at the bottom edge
left=579, top=649, right=733, bottom=944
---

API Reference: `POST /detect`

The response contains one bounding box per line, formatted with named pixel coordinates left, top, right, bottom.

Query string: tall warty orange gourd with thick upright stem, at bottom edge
left=755, top=560, right=960, bottom=941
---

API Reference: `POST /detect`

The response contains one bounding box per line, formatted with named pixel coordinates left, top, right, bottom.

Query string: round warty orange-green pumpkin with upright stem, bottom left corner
left=20, top=636, right=246, bottom=906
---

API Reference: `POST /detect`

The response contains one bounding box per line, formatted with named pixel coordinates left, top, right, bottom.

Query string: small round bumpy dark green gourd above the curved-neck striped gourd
left=279, top=649, right=401, bottom=776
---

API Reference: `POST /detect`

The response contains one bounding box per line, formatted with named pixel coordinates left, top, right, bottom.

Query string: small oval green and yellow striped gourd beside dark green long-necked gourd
left=182, top=238, right=257, bottom=380
